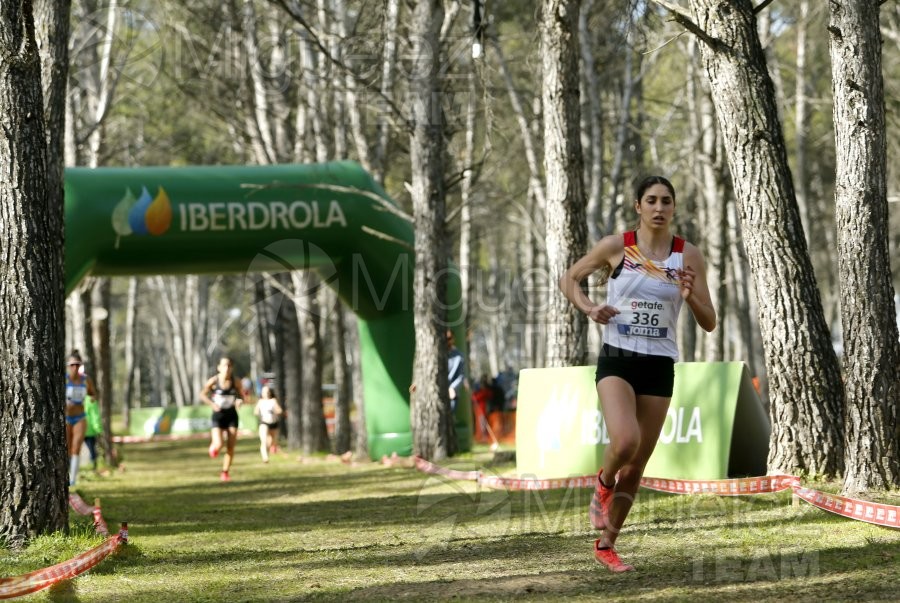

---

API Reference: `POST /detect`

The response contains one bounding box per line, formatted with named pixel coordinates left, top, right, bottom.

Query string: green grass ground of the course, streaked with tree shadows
left=0, top=437, right=900, bottom=603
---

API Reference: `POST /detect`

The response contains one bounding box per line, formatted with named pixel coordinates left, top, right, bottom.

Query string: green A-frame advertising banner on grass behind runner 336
left=516, top=362, right=770, bottom=479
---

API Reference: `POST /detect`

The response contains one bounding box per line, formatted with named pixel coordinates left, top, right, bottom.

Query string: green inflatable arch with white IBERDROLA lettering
left=65, top=162, right=471, bottom=459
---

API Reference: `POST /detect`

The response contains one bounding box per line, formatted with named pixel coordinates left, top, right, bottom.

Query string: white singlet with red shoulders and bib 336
left=603, top=231, right=684, bottom=362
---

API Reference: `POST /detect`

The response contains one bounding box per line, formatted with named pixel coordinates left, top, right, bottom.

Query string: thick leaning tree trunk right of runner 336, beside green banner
left=691, top=0, right=844, bottom=475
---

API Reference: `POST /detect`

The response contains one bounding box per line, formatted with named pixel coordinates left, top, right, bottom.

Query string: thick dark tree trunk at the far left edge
left=0, top=0, right=68, bottom=546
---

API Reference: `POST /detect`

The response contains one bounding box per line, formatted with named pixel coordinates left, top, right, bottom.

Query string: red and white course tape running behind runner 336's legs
left=414, top=457, right=900, bottom=528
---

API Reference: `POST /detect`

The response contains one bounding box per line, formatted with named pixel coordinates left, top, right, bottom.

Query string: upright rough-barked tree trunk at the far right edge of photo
left=828, top=0, right=900, bottom=493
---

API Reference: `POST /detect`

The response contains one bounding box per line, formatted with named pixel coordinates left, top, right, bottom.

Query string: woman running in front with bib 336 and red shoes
left=559, top=176, right=716, bottom=572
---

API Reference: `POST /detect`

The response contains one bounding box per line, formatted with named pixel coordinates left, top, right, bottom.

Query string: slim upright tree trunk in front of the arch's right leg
left=409, top=0, right=456, bottom=460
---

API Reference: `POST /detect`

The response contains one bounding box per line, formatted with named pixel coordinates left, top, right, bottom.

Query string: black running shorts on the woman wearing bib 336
left=594, top=343, right=675, bottom=398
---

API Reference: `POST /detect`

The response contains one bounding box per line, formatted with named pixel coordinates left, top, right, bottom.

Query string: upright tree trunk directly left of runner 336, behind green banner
left=540, top=0, right=587, bottom=366
